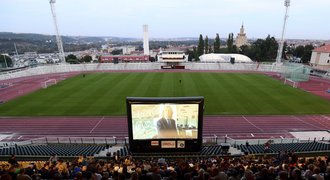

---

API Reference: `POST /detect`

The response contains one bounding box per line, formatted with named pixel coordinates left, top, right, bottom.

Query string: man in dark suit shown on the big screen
left=157, top=105, right=178, bottom=138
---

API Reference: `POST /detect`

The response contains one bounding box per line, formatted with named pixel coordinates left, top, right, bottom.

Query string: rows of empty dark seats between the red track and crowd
left=0, top=141, right=330, bottom=157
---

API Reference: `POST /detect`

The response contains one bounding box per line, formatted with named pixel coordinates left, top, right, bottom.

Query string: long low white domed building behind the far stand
left=199, top=53, right=252, bottom=63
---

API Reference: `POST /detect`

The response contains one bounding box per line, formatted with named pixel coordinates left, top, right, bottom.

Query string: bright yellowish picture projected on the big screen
left=132, top=104, right=198, bottom=140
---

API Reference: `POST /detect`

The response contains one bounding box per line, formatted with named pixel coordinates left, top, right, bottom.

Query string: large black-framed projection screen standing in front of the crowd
left=127, top=97, right=204, bottom=152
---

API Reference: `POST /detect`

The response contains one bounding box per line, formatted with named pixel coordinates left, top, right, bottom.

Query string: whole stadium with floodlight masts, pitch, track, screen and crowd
left=0, top=0, right=330, bottom=180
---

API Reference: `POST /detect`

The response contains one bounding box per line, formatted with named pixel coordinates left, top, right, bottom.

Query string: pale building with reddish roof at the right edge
left=310, top=44, right=330, bottom=70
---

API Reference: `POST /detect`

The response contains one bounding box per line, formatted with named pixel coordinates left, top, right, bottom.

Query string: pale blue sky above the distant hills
left=0, top=0, right=330, bottom=40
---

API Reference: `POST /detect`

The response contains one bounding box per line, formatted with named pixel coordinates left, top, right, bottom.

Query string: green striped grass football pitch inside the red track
left=0, top=72, right=330, bottom=116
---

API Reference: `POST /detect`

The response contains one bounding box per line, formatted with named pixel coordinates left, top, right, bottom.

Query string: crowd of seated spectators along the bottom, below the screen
left=0, top=151, right=330, bottom=180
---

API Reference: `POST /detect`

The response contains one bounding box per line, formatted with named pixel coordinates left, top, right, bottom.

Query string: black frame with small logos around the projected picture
left=126, top=96, right=204, bottom=152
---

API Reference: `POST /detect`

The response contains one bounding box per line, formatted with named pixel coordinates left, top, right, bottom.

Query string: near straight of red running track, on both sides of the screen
left=0, top=115, right=330, bottom=141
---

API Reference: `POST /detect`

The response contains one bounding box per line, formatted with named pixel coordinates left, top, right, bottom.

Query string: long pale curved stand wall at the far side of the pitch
left=0, top=62, right=281, bottom=80
